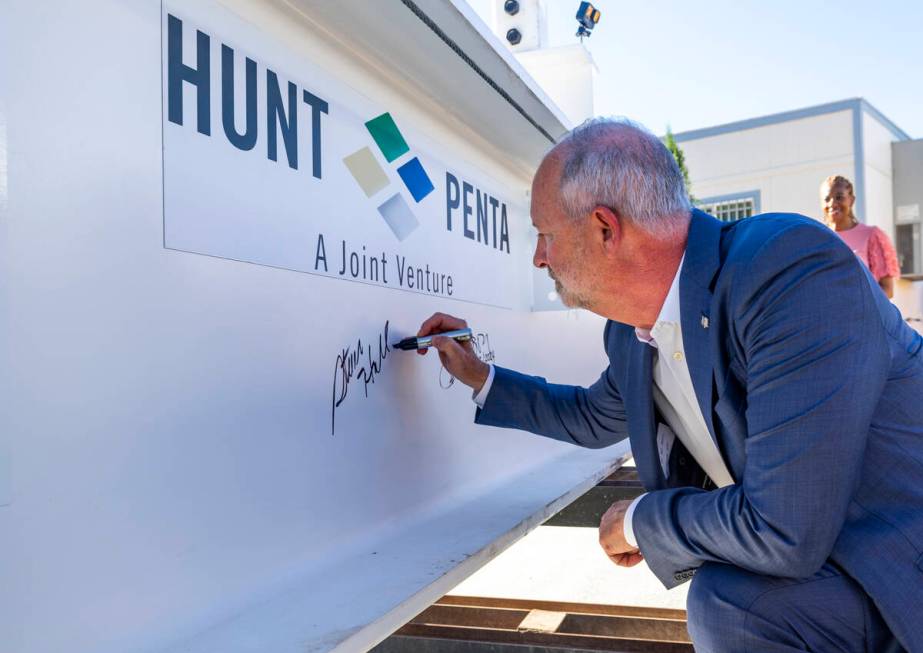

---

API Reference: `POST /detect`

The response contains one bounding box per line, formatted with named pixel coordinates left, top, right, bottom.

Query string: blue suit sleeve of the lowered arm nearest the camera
left=633, top=224, right=890, bottom=586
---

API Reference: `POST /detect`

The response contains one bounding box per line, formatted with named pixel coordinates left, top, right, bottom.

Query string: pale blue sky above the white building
left=470, top=0, right=923, bottom=138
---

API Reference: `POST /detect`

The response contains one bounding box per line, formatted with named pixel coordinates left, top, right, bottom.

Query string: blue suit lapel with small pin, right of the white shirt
left=679, top=210, right=721, bottom=451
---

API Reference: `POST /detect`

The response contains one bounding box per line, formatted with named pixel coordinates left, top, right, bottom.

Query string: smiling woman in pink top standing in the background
left=820, top=175, right=901, bottom=299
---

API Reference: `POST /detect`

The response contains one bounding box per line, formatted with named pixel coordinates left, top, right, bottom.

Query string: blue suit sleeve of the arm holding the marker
left=474, top=324, right=628, bottom=448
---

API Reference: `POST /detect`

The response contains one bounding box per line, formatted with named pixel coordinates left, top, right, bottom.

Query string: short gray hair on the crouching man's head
left=552, top=118, right=692, bottom=237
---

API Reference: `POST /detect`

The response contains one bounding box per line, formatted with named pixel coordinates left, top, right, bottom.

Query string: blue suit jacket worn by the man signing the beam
left=476, top=211, right=923, bottom=651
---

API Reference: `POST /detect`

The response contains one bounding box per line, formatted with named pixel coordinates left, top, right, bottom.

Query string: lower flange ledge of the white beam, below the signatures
left=167, top=446, right=632, bottom=653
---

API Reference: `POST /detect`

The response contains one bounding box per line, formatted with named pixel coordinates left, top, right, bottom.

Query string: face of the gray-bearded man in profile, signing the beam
left=531, top=162, right=595, bottom=309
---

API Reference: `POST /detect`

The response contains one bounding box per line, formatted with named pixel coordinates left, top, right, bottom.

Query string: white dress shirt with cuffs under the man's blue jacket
left=473, top=254, right=734, bottom=546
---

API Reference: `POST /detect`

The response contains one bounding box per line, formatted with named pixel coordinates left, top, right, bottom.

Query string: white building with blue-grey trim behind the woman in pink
left=675, top=98, right=923, bottom=317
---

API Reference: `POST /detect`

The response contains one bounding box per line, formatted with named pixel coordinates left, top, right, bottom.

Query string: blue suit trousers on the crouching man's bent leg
left=686, top=561, right=903, bottom=653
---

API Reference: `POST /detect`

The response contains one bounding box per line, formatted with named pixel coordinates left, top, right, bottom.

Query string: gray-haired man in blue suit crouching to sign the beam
left=420, top=120, right=923, bottom=653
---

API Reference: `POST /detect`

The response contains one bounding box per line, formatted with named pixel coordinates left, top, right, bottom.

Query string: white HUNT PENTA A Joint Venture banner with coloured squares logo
left=163, top=6, right=526, bottom=308
